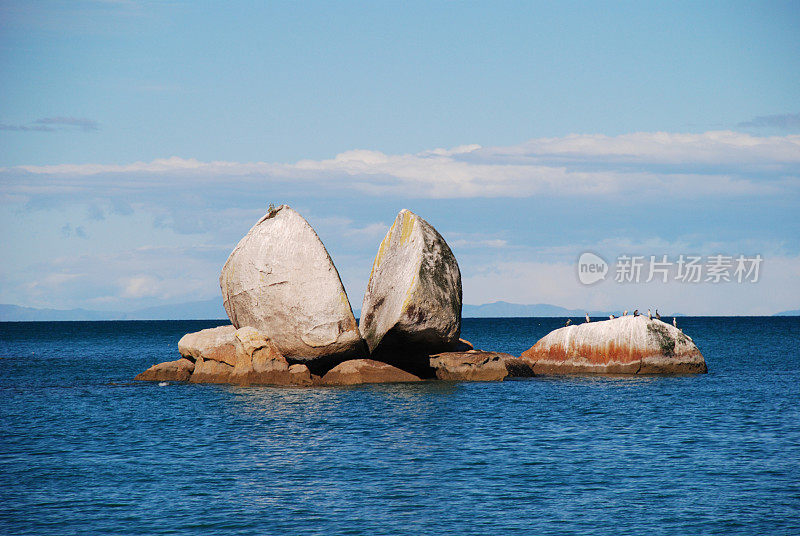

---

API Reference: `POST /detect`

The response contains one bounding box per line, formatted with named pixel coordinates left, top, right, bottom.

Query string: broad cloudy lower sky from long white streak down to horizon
left=0, top=131, right=800, bottom=314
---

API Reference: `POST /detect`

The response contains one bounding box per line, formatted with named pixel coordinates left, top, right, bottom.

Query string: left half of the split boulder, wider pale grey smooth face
left=219, top=205, right=366, bottom=369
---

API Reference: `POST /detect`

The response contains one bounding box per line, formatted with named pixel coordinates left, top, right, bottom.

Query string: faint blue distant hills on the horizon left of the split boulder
left=0, top=298, right=227, bottom=322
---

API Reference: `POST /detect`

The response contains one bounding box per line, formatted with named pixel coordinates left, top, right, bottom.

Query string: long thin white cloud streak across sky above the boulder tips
left=0, top=131, right=800, bottom=198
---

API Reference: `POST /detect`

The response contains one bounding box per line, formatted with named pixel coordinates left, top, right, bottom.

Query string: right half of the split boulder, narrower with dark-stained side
left=359, top=210, right=461, bottom=370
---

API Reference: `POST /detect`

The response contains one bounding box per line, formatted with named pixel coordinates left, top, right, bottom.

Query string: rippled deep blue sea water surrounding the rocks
left=0, top=317, right=800, bottom=536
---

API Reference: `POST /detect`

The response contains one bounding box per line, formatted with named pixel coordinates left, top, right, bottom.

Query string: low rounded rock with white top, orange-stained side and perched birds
left=521, top=316, right=707, bottom=374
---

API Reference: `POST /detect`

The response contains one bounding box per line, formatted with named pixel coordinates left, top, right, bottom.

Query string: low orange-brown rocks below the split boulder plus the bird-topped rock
left=135, top=316, right=708, bottom=387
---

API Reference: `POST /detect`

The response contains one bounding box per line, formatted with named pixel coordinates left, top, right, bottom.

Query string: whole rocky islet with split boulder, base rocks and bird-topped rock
left=135, top=205, right=707, bottom=386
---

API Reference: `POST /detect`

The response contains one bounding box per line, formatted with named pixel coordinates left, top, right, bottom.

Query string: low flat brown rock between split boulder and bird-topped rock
left=430, top=350, right=516, bottom=382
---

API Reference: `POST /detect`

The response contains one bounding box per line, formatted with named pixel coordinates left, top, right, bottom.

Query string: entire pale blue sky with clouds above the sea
left=0, top=1, right=800, bottom=314
